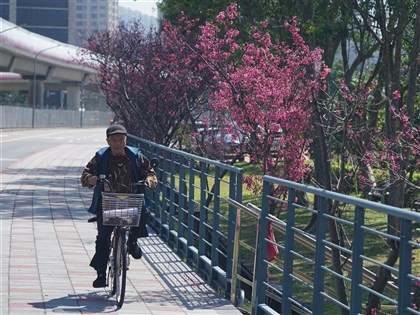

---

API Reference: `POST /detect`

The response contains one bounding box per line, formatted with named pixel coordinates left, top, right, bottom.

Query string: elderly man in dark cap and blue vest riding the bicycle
left=81, top=124, right=157, bottom=288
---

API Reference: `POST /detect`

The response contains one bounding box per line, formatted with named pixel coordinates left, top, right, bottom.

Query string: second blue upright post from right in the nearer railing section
left=350, top=206, right=365, bottom=314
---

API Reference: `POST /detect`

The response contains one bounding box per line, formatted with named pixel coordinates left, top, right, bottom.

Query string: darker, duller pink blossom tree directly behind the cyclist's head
left=79, top=20, right=210, bottom=146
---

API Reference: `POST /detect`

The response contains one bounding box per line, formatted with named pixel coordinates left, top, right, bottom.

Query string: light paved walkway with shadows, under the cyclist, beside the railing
left=0, top=130, right=241, bottom=315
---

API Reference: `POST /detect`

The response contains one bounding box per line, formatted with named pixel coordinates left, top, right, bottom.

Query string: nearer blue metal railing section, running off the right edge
left=254, top=176, right=420, bottom=314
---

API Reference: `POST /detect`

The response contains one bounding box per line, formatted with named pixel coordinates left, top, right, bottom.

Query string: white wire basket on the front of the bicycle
left=102, top=192, right=144, bottom=226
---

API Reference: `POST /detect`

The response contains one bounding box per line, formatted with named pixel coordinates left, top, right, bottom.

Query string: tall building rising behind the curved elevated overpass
left=0, top=0, right=118, bottom=46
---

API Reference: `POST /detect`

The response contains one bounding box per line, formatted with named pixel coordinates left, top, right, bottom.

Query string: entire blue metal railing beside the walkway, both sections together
left=129, top=136, right=420, bottom=315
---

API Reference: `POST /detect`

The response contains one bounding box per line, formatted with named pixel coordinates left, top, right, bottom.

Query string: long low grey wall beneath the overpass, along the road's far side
left=0, top=105, right=113, bottom=129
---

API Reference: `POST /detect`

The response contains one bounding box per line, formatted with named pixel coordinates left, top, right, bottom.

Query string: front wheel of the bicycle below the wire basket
left=112, top=229, right=127, bottom=307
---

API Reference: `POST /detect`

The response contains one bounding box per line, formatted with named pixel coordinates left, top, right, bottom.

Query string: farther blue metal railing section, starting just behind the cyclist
left=128, top=136, right=243, bottom=298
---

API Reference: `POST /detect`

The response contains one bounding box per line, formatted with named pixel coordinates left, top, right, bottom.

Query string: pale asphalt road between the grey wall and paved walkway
left=0, top=127, right=107, bottom=171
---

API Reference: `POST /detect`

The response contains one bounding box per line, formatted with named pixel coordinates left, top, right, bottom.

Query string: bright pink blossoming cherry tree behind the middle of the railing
left=164, top=4, right=328, bottom=192
